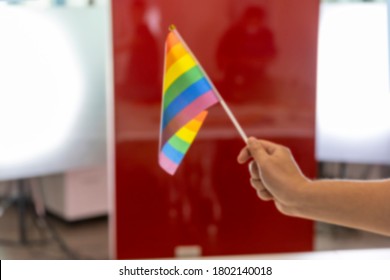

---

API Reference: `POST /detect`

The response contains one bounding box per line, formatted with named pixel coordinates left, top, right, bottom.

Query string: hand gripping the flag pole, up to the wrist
left=237, top=137, right=310, bottom=215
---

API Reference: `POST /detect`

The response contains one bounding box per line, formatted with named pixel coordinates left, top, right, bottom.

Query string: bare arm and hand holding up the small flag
left=238, top=138, right=390, bottom=235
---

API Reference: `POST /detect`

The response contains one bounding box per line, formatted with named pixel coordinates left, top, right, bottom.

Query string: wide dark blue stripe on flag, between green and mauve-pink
left=163, top=78, right=215, bottom=128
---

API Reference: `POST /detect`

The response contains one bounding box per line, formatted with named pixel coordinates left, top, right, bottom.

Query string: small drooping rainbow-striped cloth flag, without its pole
left=159, top=28, right=218, bottom=175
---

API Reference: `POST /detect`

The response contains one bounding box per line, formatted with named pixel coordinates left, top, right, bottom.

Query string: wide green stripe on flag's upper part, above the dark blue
left=164, top=66, right=204, bottom=109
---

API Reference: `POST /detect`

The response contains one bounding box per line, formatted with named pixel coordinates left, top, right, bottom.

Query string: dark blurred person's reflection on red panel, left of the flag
left=118, top=0, right=160, bottom=102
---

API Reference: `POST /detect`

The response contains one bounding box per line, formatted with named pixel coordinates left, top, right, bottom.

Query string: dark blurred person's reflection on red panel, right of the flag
left=217, top=6, right=276, bottom=99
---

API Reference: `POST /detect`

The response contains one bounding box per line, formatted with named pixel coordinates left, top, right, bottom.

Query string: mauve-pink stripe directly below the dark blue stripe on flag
left=161, top=90, right=218, bottom=143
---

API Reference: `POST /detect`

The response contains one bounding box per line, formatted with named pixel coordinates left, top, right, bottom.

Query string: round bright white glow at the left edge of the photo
left=0, top=7, right=84, bottom=166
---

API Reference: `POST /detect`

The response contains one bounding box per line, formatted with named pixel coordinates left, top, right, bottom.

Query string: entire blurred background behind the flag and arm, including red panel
left=0, top=0, right=390, bottom=259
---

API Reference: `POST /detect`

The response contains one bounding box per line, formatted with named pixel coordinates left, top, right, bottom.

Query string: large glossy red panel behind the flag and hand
left=112, top=0, right=319, bottom=259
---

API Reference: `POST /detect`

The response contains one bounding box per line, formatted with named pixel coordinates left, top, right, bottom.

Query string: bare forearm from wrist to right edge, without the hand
left=291, top=180, right=390, bottom=235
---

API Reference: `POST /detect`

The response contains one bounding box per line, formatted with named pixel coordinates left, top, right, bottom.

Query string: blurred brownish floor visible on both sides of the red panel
left=0, top=203, right=390, bottom=259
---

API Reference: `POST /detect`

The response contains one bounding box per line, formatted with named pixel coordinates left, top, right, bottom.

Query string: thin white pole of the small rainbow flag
left=169, top=24, right=248, bottom=143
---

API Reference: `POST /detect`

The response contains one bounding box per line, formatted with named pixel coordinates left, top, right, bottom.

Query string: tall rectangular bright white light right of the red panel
left=316, top=3, right=390, bottom=163
